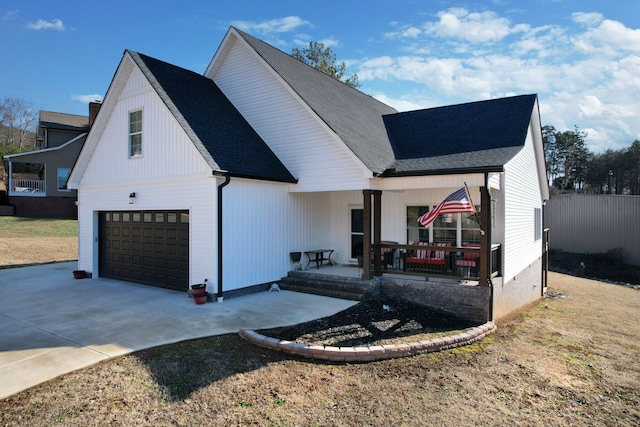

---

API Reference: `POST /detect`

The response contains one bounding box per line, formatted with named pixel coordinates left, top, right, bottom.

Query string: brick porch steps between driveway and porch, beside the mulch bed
left=278, top=271, right=373, bottom=301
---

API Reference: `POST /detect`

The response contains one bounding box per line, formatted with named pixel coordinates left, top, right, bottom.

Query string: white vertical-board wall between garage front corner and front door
left=222, top=178, right=331, bottom=291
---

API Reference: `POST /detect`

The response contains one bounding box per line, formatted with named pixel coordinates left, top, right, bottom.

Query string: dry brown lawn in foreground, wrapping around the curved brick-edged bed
left=0, top=273, right=640, bottom=426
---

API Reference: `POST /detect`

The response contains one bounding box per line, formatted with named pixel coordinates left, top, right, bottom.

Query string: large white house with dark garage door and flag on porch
left=68, top=27, right=548, bottom=320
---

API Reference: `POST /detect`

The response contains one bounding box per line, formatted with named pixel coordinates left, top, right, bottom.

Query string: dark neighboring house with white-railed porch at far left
left=3, top=103, right=100, bottom=218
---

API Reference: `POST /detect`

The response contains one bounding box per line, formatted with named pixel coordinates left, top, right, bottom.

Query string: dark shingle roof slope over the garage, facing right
left=127, top=51, right=296, bottom=182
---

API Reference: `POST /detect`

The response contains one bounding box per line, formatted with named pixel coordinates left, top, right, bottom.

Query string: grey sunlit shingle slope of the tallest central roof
left=235, top=28, right=397, bottom=173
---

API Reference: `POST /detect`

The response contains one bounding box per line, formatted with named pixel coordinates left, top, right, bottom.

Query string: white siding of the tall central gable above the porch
left=208, top=36, right=371, bottom=192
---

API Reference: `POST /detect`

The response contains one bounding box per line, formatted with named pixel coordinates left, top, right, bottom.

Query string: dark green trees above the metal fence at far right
left=542, top=125, right=640, bottom=195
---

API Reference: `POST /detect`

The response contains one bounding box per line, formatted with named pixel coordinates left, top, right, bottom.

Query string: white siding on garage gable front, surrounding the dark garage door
left=78, top=67, right=217, bottom=282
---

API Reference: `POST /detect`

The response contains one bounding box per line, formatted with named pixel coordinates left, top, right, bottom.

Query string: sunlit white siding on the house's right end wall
left=502, top=126, right=543, bottom=282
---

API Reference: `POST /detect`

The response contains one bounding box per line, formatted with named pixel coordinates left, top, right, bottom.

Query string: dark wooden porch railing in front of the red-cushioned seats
left=372, top=243, right=502, bottom=280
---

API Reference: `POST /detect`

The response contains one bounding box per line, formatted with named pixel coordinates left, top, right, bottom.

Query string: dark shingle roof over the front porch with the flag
left=384, top=95, right=537, bottom=174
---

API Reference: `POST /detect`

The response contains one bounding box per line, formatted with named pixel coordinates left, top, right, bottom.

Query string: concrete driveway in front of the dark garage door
left=0, top=262, right=354, bottom=398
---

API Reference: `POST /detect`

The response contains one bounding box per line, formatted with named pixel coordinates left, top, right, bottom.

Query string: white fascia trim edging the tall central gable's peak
left=205, top=27, right=373, bottom=178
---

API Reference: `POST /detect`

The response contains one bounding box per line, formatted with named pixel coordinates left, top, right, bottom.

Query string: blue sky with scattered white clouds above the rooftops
left=0, top=0, right=640, bottom=152
